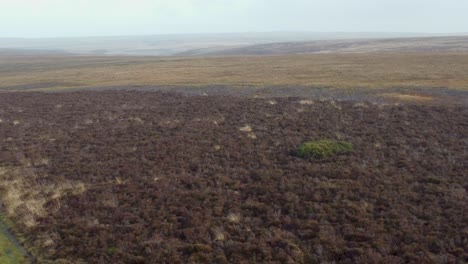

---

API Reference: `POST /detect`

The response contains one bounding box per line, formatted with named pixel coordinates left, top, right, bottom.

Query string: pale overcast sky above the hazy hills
left=0, top=0, right=468, bottom=37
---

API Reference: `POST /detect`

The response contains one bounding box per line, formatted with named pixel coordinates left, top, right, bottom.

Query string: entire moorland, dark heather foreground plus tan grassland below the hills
left=0, top=52, right=468, bottom=263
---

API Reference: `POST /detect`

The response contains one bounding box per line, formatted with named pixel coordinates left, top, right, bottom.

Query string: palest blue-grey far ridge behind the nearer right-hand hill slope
left=0, top=32, right=454, bottom=56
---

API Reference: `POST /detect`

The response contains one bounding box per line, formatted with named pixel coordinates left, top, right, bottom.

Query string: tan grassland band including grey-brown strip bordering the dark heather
left=0, top=52, right=468, bottom=105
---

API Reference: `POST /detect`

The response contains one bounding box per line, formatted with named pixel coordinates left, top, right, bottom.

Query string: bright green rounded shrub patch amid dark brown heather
left=297, top=139, right=353, bottom=159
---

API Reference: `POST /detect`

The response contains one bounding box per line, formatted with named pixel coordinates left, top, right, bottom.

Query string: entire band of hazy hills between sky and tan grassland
left=0, top=32, right=468, bottom=56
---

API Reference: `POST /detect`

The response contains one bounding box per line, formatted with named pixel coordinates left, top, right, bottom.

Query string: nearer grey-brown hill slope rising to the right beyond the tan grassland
left=177, top=36, right=468, bottom=56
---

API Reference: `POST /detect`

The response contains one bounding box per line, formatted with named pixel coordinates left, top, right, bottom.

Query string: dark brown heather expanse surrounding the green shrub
left=0, top=91, right=468, bottom=263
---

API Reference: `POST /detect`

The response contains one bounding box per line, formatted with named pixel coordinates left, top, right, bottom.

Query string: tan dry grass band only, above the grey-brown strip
left=0, top=52, right=468, bottom=91
